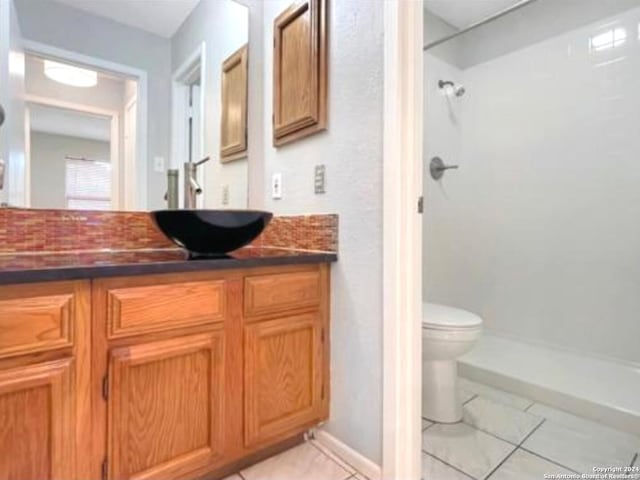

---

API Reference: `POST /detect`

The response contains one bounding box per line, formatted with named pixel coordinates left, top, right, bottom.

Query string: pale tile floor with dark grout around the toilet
left=422, top=379, right=640, bottom=480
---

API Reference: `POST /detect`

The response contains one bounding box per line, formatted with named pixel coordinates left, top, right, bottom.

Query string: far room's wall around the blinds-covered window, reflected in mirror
left=31, top=131, right=109, bottom=209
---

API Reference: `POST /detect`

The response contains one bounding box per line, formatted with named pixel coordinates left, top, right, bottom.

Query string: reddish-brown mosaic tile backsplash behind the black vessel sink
left=0, top=208, right=338, bottom=254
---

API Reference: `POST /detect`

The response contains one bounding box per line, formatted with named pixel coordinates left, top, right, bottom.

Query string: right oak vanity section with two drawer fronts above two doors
left=92, top=265, right=329, bottom=480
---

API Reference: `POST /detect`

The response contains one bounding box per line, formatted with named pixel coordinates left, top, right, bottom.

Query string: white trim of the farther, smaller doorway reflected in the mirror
left=24, top=95, right=123, bottom=210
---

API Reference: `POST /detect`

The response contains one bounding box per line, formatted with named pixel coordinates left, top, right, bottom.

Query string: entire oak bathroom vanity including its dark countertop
left=0, top=253, right=335, bottom=480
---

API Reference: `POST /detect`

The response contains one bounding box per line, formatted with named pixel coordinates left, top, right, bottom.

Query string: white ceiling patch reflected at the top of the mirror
left=55, top=0, right=200, bottom=38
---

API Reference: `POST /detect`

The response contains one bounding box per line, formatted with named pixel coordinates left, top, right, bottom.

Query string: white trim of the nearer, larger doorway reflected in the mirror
left=23, top=40, right=149, bottom=210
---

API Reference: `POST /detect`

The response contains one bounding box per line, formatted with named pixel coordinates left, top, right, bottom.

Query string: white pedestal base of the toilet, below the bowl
left=422, top=360, right=462, bottom=423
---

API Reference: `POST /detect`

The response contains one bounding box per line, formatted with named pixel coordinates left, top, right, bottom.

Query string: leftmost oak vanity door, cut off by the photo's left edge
left=0, top=359, right=75, bottom=480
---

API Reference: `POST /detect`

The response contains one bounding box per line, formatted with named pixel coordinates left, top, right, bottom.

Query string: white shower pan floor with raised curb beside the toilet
left=459, top=334, right=640, bottom=435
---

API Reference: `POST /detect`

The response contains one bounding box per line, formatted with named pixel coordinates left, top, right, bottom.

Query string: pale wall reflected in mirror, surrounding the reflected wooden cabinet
left=171, top=0, right=249, bottom=208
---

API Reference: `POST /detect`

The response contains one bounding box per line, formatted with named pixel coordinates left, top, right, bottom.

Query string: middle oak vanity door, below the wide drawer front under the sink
left=108, top=329, right=224, bottom=480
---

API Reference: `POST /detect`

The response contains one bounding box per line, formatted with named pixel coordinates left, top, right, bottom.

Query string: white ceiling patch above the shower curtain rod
left=424, top=0, right=521, bottom=29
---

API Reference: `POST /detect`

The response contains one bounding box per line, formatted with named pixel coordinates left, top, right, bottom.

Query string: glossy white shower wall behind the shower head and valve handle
left=424, top=8, right=640, bottom=364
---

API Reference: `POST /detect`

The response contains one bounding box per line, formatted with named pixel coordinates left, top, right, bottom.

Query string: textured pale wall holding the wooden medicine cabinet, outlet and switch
left=264, top=0, right=383, bottom=463
